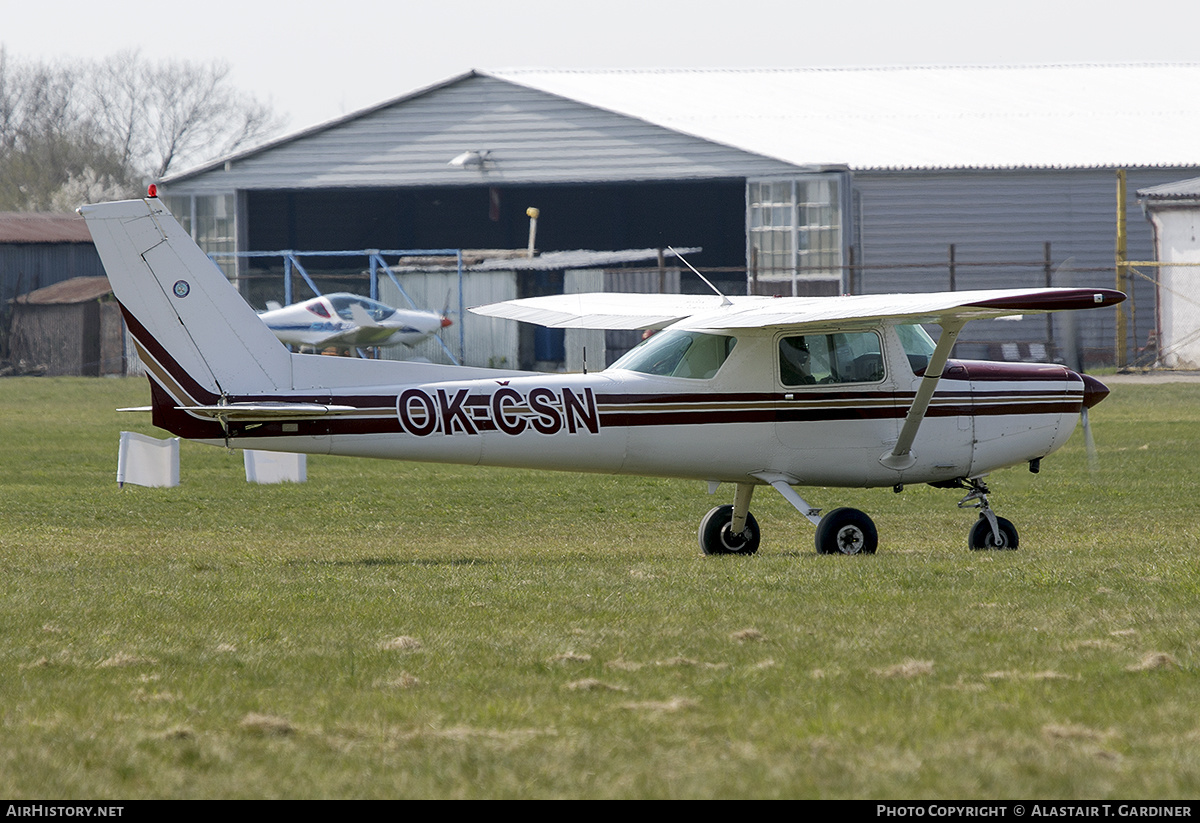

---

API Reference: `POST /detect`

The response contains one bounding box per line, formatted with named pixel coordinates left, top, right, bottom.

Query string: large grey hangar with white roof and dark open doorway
left=160, top=65, right=1200, bottom=364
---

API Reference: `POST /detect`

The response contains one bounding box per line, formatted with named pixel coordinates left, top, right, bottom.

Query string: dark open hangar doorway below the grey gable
left=245, top=180, right=745, bottom=289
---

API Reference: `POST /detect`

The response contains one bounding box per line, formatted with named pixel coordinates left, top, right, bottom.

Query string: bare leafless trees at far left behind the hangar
left=0, top=46, right=282, bottom=210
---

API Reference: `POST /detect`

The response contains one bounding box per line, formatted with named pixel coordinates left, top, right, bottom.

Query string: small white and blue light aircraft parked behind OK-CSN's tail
left=258, top=293, right=452, bottom=352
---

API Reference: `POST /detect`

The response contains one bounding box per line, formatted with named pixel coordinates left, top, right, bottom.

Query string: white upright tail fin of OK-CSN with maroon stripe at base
left=79, top=198, right=293, bottom=404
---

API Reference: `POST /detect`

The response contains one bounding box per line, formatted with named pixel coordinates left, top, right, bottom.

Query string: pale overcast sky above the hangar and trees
left=0, top=0, right=1200, bottom=133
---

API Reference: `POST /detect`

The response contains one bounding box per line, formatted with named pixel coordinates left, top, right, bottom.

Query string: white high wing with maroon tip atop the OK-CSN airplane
left=470, top=288, right=1124, bottom=330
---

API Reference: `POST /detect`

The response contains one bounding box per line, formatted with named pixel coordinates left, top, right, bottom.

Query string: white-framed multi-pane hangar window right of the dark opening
left=746, top=174, right=845, bottom=294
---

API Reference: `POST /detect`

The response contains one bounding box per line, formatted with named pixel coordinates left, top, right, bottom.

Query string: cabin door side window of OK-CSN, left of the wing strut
left=779, top=331, right=883, bottom=386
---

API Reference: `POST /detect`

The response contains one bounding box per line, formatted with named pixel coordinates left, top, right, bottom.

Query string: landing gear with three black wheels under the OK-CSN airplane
left=700, top=474, right=1020, bottom=554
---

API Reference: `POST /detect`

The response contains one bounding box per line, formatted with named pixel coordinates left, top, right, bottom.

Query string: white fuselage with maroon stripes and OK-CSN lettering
left=214, top=326, right=1084, bottom=487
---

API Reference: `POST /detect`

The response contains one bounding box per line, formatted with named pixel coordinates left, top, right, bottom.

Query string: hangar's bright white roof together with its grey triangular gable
left=163, top=64, right=1200, bottom=193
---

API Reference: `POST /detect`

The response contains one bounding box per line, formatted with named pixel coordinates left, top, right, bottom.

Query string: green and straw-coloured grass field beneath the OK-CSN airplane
left=0, top=378, right=1200, bottom=800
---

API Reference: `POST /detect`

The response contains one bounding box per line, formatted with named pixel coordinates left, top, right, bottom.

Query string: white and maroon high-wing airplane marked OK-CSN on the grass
left=80, top=197, right=1124, bottom=554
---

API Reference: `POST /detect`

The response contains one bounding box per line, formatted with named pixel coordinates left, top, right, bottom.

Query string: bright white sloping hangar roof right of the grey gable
left=482, top=64, right=1200, bottom=170
